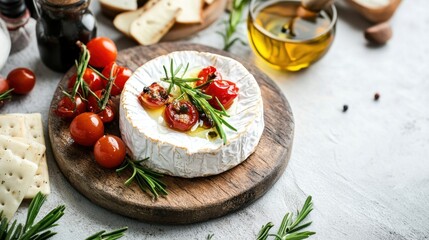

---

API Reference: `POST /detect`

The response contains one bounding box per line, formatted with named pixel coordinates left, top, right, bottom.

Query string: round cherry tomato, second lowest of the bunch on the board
left=70, top=112, right=104, bottom=146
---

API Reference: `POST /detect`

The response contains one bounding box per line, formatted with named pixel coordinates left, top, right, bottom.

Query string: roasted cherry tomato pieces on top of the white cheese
left=138, top=66, right=238, bottom=131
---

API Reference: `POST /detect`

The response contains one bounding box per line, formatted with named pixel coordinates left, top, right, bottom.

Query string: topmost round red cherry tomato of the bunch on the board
left=86, top=37, right=118, bottom=68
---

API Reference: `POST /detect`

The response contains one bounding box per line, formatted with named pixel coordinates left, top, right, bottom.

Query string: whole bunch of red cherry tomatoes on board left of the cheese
left=53, top=37, right=132, bottom=168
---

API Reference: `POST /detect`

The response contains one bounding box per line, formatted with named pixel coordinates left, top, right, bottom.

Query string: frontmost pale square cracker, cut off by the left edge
left=0, top=141, right=38, bottom=219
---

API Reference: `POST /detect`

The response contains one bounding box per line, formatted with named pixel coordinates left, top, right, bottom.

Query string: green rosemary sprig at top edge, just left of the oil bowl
left=217, top=0, right=250, bottom=51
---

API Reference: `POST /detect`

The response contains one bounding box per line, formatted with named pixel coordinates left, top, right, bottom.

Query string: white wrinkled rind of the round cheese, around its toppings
left=120, top=51, right=264, bottom=178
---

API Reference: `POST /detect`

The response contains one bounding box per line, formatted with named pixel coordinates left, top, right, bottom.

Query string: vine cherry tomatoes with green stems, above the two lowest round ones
left=54, top=37, right=132, bottom=123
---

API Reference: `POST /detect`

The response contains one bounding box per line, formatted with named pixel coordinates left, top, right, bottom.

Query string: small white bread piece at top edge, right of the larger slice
left=170, top=0, right=204, bottom=24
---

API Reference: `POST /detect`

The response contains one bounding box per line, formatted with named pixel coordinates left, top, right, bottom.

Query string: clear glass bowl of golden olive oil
left=247, top=0, right=337, bottom=71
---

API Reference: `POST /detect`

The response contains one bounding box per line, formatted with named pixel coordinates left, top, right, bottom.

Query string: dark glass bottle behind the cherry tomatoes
left=36, top=0, right=97, bottom=72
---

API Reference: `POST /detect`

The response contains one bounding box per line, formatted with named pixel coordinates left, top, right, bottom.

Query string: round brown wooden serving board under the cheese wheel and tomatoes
left=48, top=43, right=294, bottom=224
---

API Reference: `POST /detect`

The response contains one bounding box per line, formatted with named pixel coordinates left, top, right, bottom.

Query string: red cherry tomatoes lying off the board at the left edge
left=0, top=68, right=36, bottom=107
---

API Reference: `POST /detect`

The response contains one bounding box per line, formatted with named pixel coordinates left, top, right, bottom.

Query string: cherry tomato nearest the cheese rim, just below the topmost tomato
left=102, top=62, right=133, bottom=96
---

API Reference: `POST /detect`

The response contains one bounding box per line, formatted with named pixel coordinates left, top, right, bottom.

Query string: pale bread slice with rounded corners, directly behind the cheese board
left=130, top=0, right=180, bottom=45
